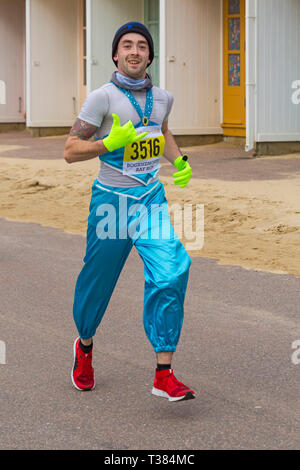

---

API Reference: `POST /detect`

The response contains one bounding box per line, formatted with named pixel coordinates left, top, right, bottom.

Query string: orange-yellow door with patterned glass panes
left=221, top=0, right=246, bottom=137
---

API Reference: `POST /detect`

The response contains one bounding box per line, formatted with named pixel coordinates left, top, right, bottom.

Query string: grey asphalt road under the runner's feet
left=0, top=220, right=300, bottom=450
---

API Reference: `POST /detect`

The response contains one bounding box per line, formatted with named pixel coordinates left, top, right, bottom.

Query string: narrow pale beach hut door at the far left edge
left=0, top=0, right=25, bottom=123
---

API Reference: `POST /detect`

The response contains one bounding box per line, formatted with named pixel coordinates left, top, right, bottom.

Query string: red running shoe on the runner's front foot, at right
left=152, top=369, right=195, bottom=401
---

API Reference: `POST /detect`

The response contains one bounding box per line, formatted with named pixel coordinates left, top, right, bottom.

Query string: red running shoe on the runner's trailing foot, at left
left=71, top=338, right=95, bottom=390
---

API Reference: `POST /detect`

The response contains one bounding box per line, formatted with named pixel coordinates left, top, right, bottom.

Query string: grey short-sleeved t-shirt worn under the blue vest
left=78, top=83, right=173, bottom=187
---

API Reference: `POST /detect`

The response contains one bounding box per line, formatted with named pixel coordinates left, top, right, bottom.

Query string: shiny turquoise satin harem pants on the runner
left=73, top=180, right=191, bottom=353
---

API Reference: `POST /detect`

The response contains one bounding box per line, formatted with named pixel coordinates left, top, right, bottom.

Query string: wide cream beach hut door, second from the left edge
left=26, top=0, right=80, bottom=128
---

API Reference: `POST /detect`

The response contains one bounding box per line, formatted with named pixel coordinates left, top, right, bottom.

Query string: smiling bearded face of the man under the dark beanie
left=114, top=33, right=150, bottom=80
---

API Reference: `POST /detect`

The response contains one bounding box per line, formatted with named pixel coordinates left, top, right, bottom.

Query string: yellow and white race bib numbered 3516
left=123, top=126, right=165, bottom=175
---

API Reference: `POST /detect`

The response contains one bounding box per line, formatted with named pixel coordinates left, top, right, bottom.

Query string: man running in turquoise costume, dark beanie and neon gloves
left=64, top=22, right=195, bottom=401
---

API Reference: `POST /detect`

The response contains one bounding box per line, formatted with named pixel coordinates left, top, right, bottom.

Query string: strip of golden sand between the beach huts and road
left=0, top=157, right=300, bottom=276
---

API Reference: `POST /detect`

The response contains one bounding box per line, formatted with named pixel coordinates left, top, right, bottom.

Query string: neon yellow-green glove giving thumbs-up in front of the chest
left=103, top=113, right=148, bottom=152
